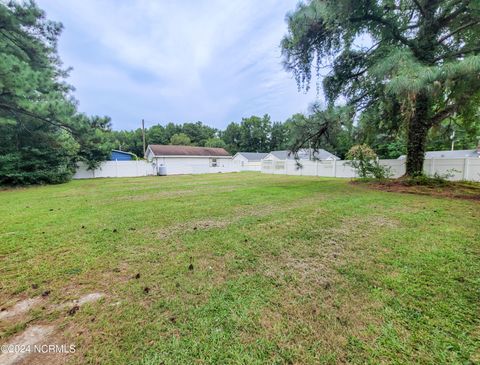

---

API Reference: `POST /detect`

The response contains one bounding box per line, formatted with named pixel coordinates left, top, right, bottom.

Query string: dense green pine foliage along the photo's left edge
left=0, top=1, right=109, bottom=184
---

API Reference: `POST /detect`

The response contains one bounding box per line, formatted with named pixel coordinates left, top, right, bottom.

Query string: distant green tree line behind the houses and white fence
left=105, top=104, right=480, bottom=159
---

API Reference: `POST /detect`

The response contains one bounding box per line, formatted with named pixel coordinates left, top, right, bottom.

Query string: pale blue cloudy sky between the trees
left=37, top=0, right=317, bottom=130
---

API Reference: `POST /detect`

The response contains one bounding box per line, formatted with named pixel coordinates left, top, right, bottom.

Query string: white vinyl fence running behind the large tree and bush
left=261, top=158, right=480, bottom=181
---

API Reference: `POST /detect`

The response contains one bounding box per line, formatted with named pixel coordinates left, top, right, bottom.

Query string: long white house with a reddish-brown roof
left=145, top=144, right=237, bottom=175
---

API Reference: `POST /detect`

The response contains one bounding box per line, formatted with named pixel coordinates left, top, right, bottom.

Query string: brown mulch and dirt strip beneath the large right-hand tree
left=352, top=179, right=480, bottom=202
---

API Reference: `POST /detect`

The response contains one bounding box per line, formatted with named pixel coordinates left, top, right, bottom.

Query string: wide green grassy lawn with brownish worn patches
left=0, top=173, right=480, bottom=365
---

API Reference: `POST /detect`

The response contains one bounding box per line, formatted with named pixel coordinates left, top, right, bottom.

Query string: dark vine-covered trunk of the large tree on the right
left=406, top=93, right=431, bottom=176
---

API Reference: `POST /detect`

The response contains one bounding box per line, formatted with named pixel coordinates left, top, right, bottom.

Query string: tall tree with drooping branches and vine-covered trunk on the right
left=282, top=0, right=480, bottom=175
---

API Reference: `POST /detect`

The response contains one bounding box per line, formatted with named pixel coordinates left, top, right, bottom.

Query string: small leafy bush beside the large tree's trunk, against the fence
left=347, top=144, right=392, bottom=179
